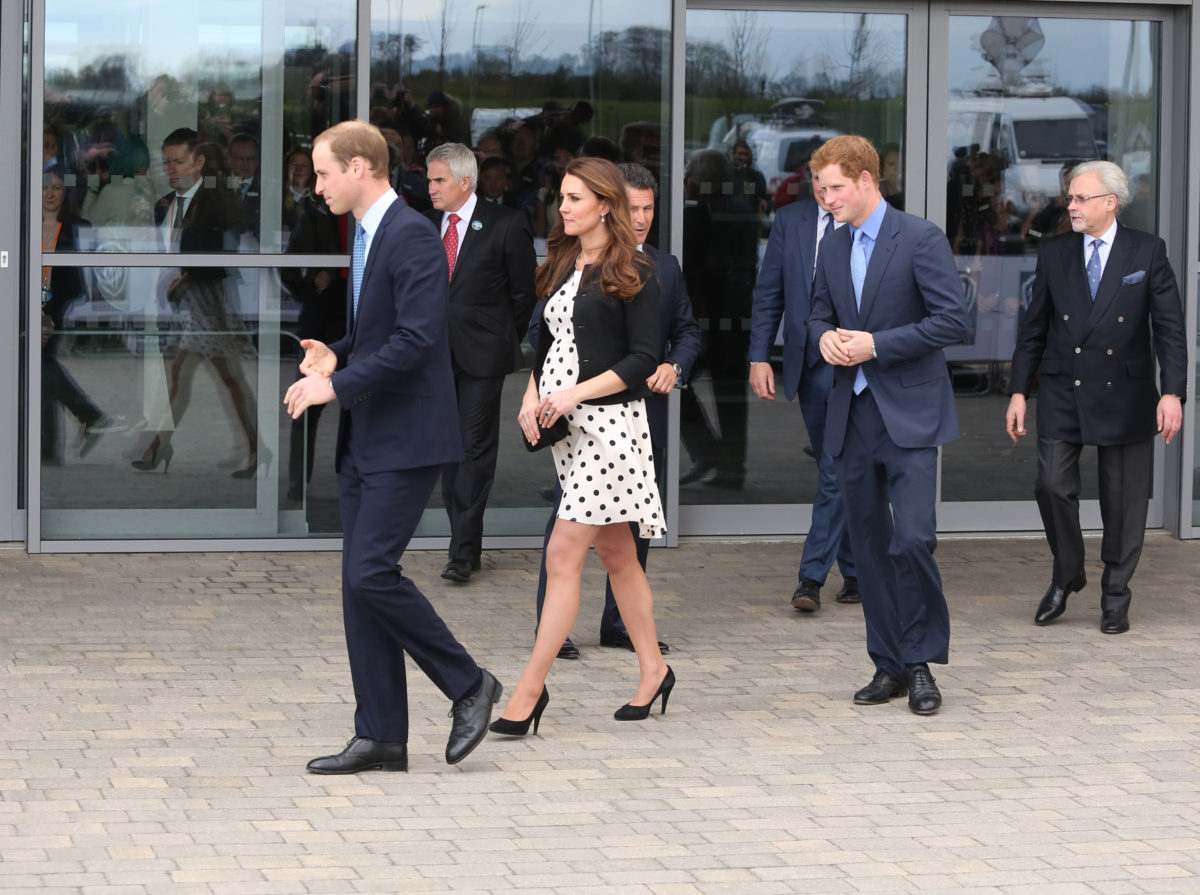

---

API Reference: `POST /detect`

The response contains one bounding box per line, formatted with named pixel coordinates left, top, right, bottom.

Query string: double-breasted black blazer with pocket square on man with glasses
left=1010, top=224, right=1188, bottom=445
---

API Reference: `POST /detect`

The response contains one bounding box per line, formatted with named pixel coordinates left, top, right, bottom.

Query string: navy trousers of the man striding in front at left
left=337, top=446, right=480, bottom=743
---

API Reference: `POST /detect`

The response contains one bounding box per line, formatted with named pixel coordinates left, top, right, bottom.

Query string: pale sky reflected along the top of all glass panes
left=46, top=0, right=1157, bottom=97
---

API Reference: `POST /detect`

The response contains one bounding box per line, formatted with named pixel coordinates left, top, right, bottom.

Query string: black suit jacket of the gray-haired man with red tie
left=425, top=199, right=538, bottom=377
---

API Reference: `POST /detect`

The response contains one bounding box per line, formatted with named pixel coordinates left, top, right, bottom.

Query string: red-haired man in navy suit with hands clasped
left=809, top=136, right=967, bottom=715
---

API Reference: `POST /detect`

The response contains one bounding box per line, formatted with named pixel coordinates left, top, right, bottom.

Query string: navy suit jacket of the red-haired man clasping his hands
left=809, top=206, right=967, bottom=457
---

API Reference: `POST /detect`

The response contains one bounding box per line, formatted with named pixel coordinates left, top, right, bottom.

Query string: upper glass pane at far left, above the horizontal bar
left=42, top=0, right=356, bottom=252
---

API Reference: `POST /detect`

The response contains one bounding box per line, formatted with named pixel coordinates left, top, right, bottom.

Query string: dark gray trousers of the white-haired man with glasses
left=1033, top=436, right=1154, bottom=612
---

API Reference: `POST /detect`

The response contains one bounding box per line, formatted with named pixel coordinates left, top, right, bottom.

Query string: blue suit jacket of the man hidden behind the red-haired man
left=750, top=199, right=820, bottom=401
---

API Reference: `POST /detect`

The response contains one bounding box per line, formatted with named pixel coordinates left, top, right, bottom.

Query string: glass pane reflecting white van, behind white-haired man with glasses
left=930, top=16, right=1160, bottom=500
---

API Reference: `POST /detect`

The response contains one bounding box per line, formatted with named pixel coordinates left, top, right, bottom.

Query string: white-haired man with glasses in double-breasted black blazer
left=1006, top=162, right=1188, bottom=633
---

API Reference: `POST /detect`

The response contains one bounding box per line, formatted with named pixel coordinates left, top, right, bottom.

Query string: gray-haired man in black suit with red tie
left=425, top=143, right=538, bottom=584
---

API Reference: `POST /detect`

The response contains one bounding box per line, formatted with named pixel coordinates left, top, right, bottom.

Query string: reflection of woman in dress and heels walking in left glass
left=131, top=143, right=262, bottom=479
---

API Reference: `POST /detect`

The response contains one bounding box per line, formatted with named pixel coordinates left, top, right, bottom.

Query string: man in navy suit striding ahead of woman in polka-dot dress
left=284, top=121, right=502, bottom=774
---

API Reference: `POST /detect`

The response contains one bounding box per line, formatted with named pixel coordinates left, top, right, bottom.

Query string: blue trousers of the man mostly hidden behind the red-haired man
left=796, top=364, right=858, bottom=584
